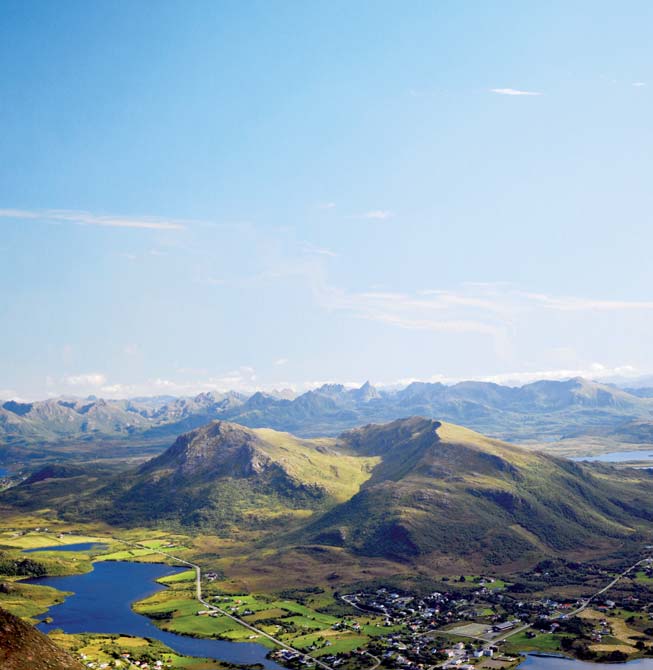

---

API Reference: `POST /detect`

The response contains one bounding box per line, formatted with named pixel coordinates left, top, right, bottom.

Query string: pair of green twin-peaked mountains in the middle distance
left=8, top=417, right=653, bottom=569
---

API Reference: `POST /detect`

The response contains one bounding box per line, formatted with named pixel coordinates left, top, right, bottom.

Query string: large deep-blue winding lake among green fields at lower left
left=26, top=561, right=284, bottom=670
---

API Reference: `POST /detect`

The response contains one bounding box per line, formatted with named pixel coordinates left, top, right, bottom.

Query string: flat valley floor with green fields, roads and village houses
left=0, top=515, right=653, bottom=670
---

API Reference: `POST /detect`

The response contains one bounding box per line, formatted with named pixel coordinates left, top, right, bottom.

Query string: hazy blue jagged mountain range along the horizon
left=0, top=378, right=653, bottom=460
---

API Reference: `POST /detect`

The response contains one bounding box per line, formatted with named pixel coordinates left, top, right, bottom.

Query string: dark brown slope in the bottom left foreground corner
left=0, top=608, right=84, bottom=670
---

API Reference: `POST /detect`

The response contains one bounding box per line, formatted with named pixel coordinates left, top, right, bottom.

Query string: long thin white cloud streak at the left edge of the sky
left=0, top=209, right=192, bottom=230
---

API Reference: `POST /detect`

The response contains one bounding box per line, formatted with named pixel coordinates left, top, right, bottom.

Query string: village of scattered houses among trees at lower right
left=264, top=563, right=653, bottom=670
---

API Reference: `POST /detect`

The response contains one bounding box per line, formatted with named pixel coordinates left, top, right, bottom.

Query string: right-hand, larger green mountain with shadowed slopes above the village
left=294, top=418, right=653, bottom=564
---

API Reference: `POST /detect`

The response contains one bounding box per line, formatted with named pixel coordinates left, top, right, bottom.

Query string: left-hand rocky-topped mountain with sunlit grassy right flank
left=65, top=421, right=378, bottom=532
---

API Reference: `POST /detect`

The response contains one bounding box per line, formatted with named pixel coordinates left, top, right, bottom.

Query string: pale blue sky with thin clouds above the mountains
left=0, top=0, right=653, bottom=398
